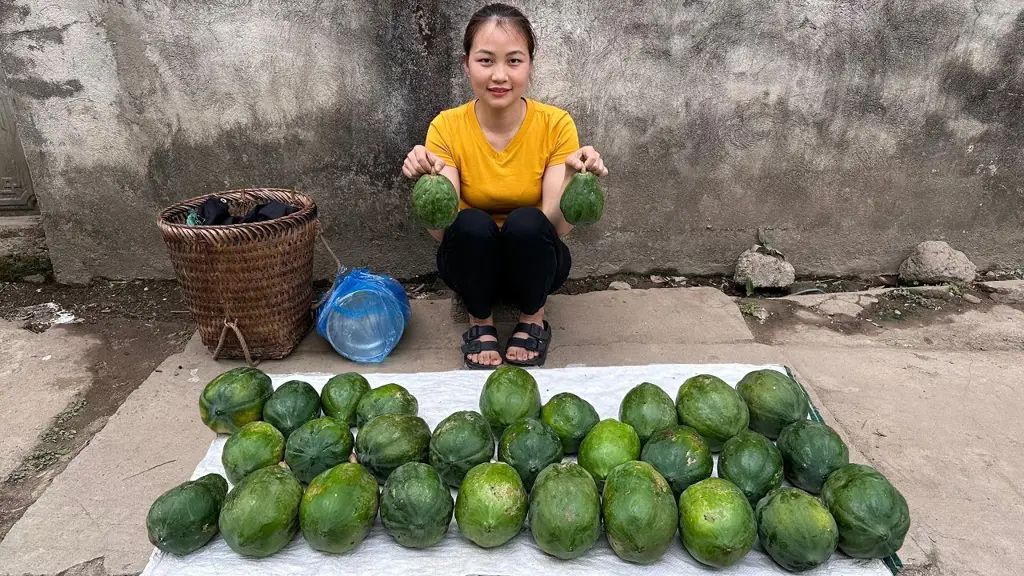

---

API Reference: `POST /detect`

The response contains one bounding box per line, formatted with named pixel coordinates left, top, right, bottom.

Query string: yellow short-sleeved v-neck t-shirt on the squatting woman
left=425, top=98, right=580, bottom=225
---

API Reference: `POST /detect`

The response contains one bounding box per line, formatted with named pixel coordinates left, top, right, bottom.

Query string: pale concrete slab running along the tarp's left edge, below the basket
left=0, top=353, right=222, bottom=575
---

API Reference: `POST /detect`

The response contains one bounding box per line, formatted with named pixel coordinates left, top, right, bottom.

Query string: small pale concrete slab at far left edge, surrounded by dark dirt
left=0, top=321, right=99, bottom=477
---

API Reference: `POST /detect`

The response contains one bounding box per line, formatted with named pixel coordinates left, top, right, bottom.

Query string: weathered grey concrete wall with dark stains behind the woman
left=0, top=0, right=1024, bottom=281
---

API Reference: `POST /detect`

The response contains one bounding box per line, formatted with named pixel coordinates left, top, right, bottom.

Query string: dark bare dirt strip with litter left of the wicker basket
left=0, top=281, right=195, bottom=539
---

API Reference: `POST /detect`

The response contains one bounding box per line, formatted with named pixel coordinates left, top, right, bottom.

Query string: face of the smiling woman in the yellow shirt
left=464, top=19, right=530, bottom=109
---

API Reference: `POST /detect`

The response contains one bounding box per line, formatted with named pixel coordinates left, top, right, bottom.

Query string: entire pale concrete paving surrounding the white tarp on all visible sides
left=0, top=288, right=1024, bottom=576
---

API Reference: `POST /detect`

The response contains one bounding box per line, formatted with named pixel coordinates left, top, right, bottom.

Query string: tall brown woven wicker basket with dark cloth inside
left=157, top=189, right=326, bottom=366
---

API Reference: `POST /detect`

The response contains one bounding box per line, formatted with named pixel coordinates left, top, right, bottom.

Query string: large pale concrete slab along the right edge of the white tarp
left=783, top=346, right=1024, bottom=576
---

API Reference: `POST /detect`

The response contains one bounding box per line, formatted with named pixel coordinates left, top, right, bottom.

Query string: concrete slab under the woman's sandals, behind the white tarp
left=249, top=288, right=754, bottom=372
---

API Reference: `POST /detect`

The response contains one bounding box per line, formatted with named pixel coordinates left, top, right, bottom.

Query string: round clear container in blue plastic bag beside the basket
left=316, top=269, right=412, bottom=363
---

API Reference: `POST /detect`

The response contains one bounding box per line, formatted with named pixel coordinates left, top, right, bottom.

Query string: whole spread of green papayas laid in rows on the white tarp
left=151, top=366, right=909, bottom=569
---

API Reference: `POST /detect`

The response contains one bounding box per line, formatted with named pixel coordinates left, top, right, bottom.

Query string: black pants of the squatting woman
left=437, top=207, right=572, bottom=318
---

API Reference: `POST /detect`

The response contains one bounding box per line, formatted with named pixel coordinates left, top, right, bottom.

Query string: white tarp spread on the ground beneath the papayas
left=142, top=364, right=891, bottom=576
